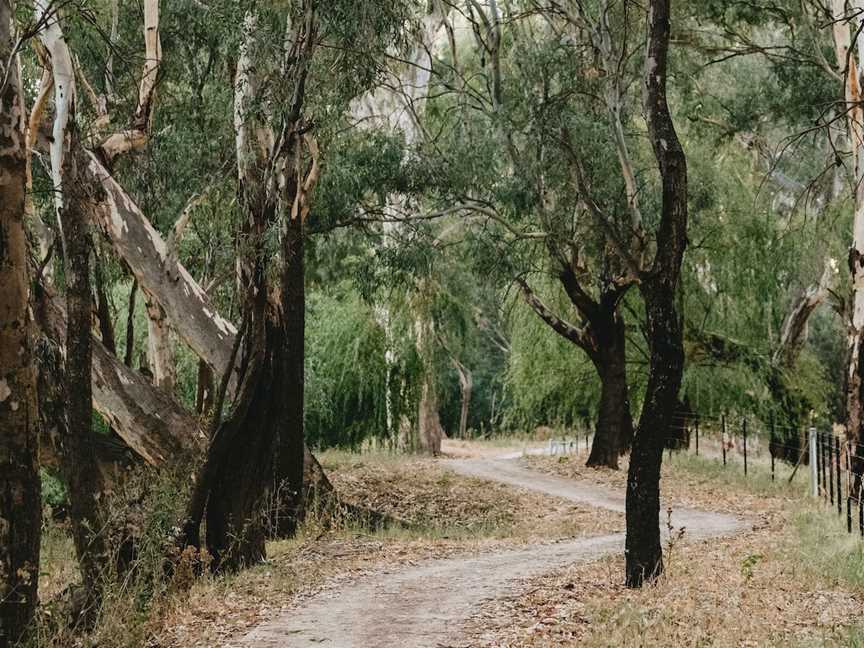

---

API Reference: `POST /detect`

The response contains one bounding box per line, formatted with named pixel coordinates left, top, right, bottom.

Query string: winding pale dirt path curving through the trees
left=231, top=459, right=747, bottom=648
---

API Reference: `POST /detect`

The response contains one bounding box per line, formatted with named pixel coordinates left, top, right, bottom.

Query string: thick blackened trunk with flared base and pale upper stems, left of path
left=183, top=2, right=318, bottom=569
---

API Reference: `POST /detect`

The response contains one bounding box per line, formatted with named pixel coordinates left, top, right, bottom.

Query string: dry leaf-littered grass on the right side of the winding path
left=466, top=456, right=864, bottom=648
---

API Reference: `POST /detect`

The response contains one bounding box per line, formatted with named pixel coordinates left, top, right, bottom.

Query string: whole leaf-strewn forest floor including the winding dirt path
left=37, top=442, right=864, bottom=648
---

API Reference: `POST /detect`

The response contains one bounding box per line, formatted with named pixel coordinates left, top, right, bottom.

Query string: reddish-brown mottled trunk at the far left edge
left=0, top=0, right=42, bottom=636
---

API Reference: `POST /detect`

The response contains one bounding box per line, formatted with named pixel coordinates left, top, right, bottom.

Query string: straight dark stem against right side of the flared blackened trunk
left=274, top=218, right=306, bottom=538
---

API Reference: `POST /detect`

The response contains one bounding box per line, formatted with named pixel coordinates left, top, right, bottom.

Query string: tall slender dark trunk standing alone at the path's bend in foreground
left=625, top=0, right=687, bottom=587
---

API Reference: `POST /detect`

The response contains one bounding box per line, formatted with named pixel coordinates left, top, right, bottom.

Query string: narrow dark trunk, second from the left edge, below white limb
left=60, top=139, right=108, bottom=623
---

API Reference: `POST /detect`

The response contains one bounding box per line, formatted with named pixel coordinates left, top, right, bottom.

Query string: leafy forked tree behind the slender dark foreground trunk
left=418, top=3, right=642, bottom=467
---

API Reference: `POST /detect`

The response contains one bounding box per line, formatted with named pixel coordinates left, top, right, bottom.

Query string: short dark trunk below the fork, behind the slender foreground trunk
left=586, top=313, right=633, bottom=469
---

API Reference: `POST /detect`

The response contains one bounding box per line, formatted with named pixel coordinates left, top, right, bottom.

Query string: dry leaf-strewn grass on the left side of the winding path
left=32, top=444, right=623, bottom=648
